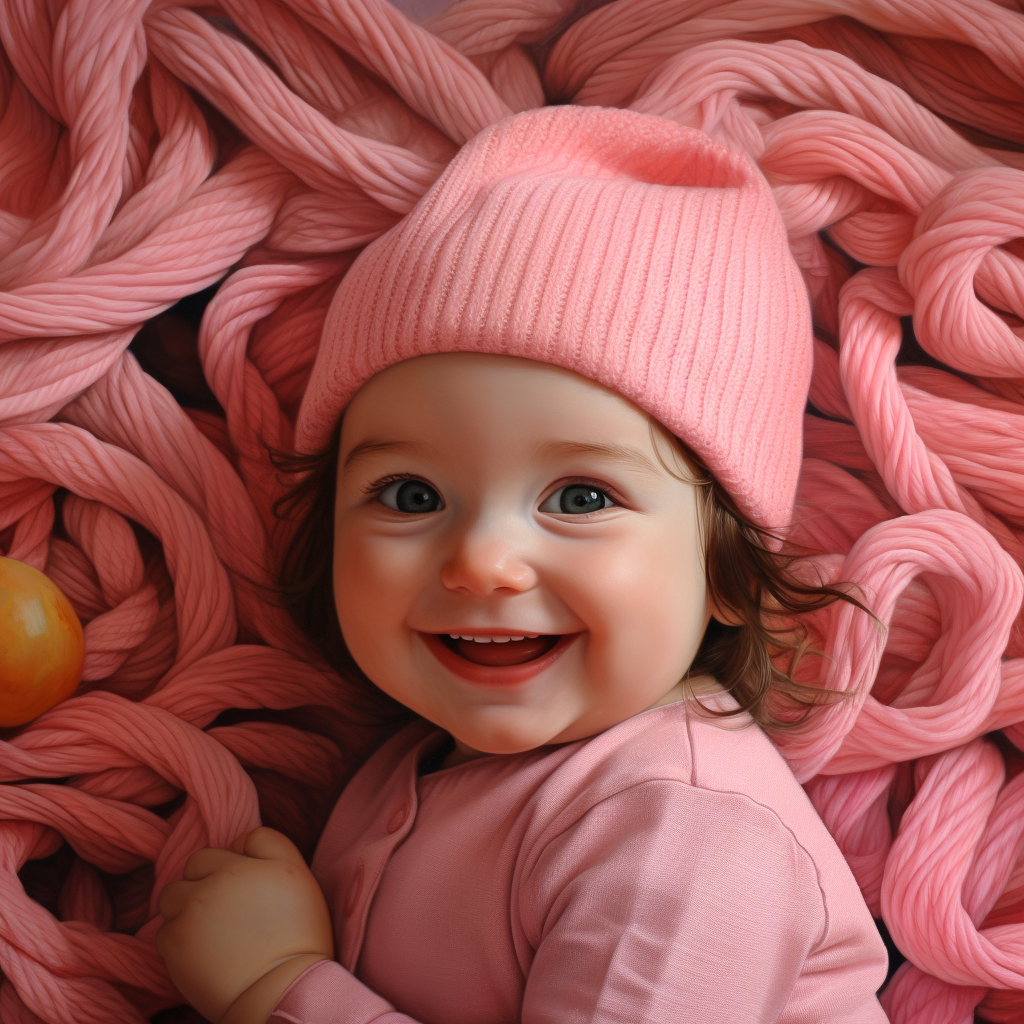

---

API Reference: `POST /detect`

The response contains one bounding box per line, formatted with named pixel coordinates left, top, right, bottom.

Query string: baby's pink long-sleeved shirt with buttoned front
left=270, top=693, right=887, bottom=1024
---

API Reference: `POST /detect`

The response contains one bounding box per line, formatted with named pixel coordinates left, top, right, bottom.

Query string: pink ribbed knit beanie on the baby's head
left=296, top=106, right=812, bottom=529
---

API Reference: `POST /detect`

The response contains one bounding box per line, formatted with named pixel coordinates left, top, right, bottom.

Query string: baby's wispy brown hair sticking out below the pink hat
left=272, top=420, right=878, bottom=729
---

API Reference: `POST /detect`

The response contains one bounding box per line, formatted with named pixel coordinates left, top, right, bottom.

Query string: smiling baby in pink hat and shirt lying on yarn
left=158, top=106, right=886, bottom=1024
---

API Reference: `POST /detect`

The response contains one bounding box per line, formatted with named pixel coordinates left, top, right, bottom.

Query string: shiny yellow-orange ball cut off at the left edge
left=0, top=558, right=85, bottom=727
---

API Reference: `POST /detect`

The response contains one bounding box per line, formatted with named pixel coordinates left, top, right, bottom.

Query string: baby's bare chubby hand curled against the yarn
left=157, top=828, right=334, bottom=1022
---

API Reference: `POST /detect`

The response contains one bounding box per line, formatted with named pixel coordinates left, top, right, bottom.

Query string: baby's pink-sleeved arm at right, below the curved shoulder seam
left=519, top=779, right=886, bottom=1024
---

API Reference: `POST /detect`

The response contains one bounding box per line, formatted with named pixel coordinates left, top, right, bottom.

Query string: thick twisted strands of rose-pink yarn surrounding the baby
left=0, top=0, right=1024, bottom=1024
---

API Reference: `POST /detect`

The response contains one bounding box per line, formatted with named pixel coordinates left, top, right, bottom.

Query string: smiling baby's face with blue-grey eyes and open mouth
left=334, top=353, right=710, bottom=754
